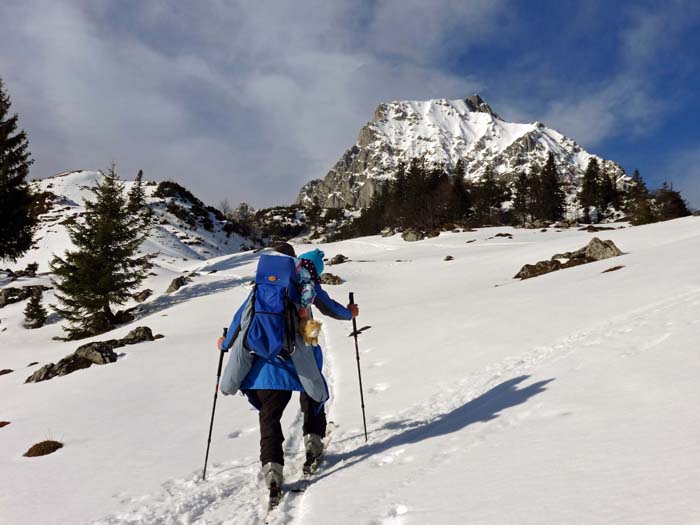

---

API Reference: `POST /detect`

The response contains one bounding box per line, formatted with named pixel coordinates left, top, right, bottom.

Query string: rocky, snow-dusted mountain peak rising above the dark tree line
left=297, top=95, right=624, bottom=208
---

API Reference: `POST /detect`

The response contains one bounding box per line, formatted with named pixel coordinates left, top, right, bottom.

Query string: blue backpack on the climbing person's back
left=241, top=255, right=299, bottom=359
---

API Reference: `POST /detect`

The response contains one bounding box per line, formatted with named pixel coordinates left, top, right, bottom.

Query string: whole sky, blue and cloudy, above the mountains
left=0, top=0, right=700, bottom=208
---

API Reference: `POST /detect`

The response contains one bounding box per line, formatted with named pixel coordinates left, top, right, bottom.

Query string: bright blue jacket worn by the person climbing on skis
left=223, top=284, right=352, bottom=400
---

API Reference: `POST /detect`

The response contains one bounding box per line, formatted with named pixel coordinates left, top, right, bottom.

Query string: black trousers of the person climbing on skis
left=247, top=390, right=326, bottom=465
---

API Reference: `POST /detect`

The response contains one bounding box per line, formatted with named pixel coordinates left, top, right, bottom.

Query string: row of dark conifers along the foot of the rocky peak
left=352, top=153, right=690, bottom=236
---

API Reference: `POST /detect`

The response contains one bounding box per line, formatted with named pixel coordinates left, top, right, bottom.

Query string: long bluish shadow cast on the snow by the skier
left=314, top=375, right=554, bottom=482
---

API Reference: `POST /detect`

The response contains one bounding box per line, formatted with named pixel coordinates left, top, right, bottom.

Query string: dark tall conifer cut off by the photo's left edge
left=0, top=79, right=36, bottom=261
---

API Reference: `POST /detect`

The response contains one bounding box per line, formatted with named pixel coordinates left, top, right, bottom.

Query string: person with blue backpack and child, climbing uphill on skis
left=218, top=243, right=359, bottom=501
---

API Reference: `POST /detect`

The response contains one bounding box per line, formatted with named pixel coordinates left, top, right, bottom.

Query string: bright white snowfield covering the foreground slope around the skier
left=0, top=217, right=700, bottom=525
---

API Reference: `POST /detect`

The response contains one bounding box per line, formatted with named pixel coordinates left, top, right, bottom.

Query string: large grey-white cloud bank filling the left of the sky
left=0, top=0, right=501, bottom=204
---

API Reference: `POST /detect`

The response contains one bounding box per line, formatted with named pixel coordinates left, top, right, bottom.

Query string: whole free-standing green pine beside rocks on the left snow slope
left=50, top=166, right=151, bottom=339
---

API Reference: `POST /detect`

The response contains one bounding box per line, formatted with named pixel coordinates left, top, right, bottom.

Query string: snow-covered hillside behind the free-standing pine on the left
left=11, top=171, right=257, bottom=271
